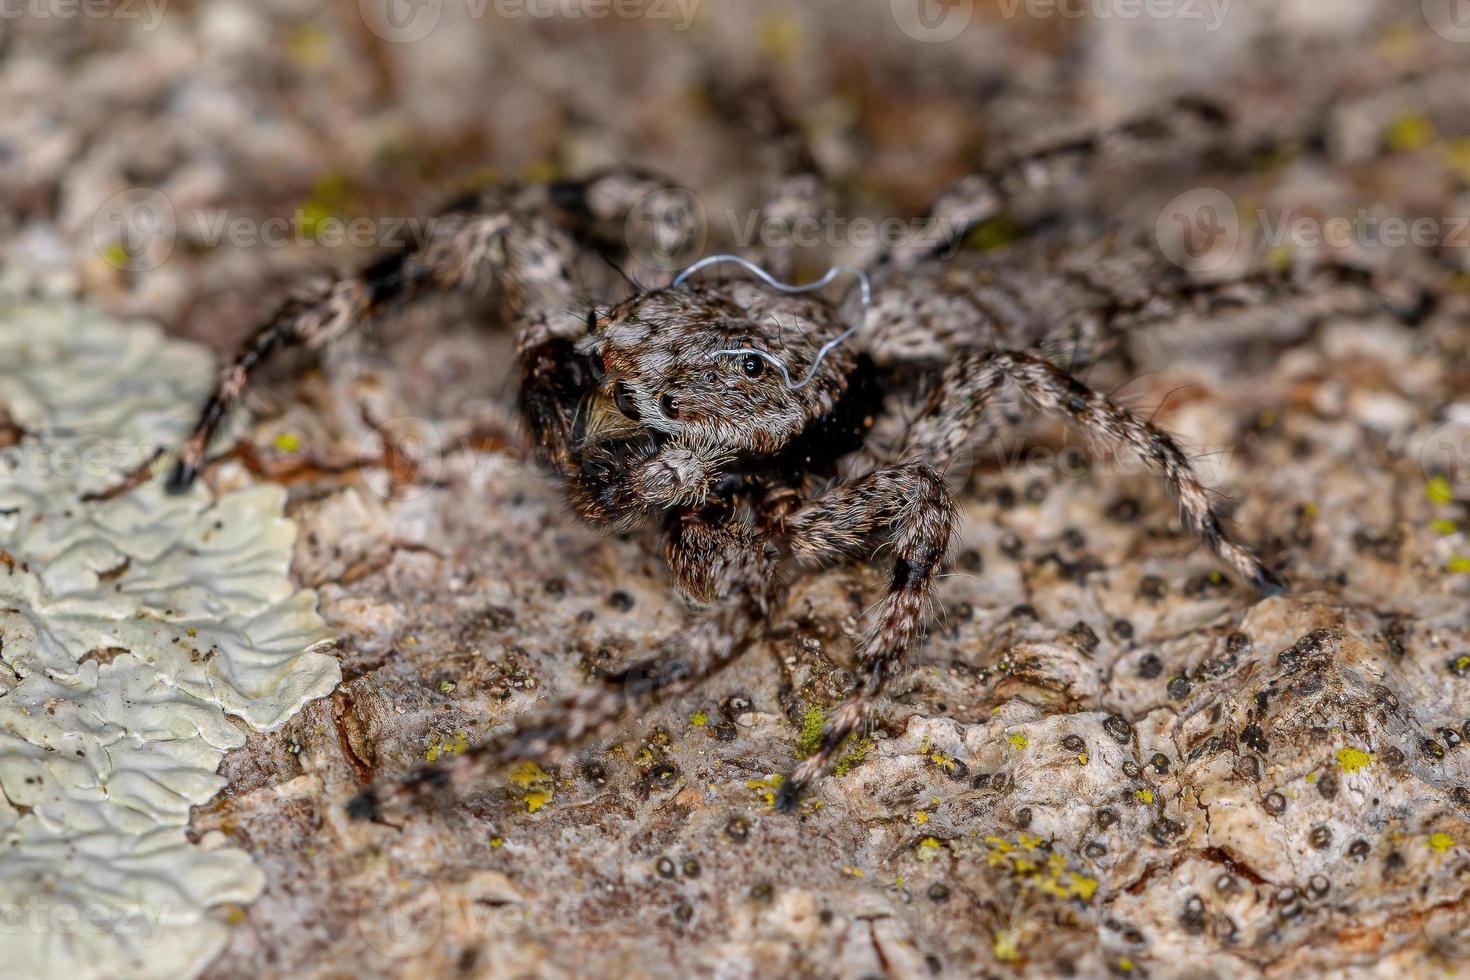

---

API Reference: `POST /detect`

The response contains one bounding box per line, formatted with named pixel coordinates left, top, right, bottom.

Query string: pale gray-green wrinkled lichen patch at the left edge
left=0, top=300, right=341, bottom=977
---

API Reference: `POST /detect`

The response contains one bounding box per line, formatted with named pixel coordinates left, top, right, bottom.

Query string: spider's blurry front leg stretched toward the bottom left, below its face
left=347, top=517, right=782, bottom=818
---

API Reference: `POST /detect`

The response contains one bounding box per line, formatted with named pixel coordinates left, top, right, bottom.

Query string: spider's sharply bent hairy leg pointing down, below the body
left=778, top=461, right=956, bottom=810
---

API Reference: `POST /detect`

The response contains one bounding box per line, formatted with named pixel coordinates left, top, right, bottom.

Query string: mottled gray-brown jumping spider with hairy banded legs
left=171, top=95, right=1428, bottom=815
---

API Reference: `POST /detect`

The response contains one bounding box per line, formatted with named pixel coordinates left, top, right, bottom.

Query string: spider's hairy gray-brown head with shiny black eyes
left=546, top=281, right=853, bottom=529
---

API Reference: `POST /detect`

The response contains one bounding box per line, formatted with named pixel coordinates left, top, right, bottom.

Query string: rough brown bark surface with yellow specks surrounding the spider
left=0, top=0, right=1470, bottom=977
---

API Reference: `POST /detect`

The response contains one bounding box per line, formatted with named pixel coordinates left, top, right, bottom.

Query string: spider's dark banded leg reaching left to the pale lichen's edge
left=168, top=213, right=529, bottom=492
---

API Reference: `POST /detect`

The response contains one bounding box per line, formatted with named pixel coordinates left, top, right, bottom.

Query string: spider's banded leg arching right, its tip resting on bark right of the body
left=907, top=351, right=1286, bottom=595
